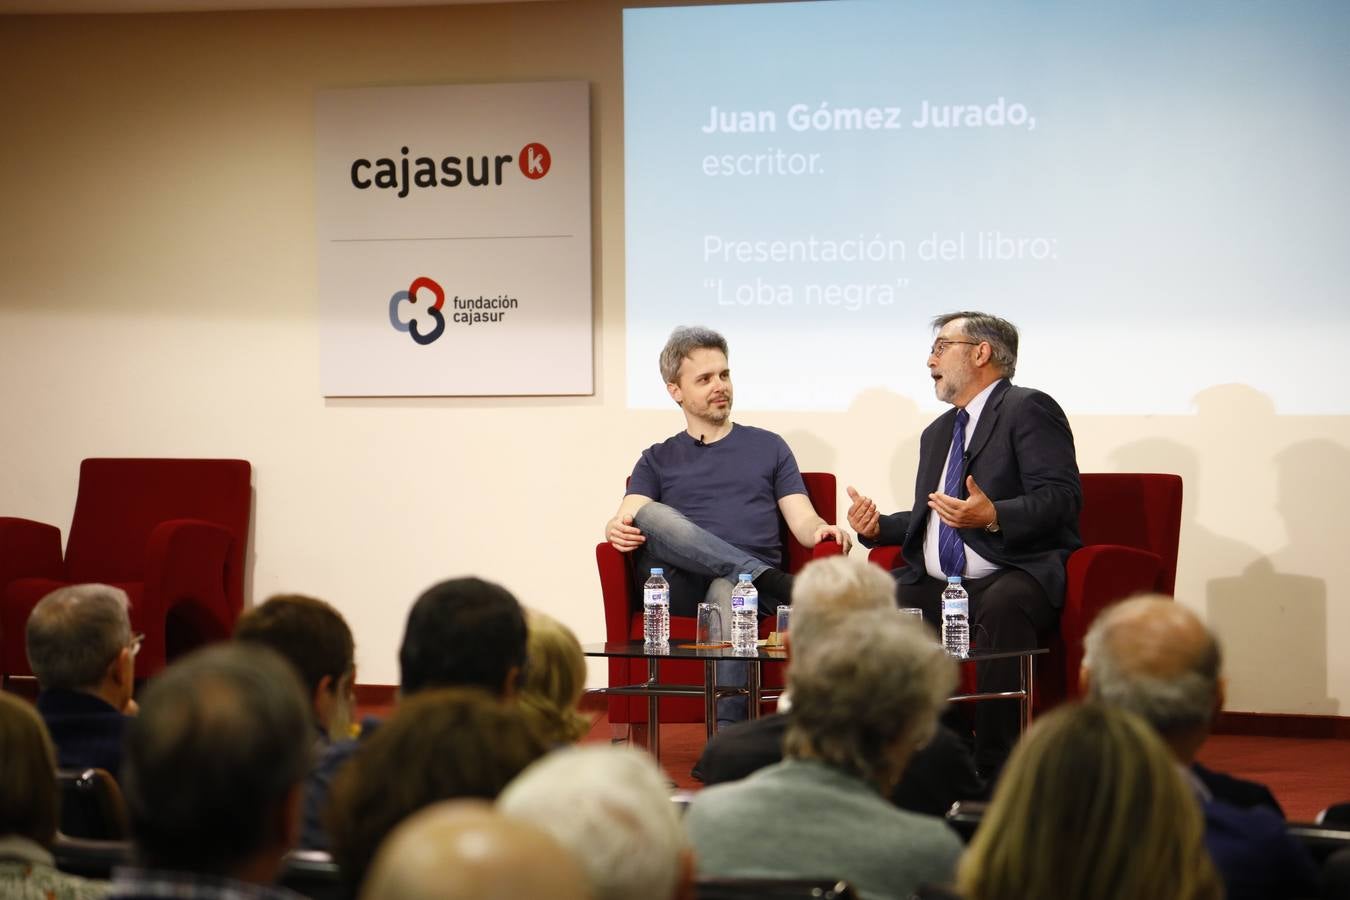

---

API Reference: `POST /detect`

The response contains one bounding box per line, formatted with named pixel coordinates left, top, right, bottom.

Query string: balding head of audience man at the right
left=1083, top=596, right=1222, bottom=749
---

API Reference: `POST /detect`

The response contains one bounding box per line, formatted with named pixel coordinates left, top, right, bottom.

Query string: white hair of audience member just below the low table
left=791, top=556, right=895, bottom=654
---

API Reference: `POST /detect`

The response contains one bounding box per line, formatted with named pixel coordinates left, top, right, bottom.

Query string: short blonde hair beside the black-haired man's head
left=517, top=610, right=590, bottom=743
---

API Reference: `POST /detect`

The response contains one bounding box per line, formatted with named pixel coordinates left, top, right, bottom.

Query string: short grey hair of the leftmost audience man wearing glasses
left=26, top=584, right=131, bottom=691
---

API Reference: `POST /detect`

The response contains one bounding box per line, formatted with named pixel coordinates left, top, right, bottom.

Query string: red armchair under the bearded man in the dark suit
left=868, top=472, right=1181, bottom=714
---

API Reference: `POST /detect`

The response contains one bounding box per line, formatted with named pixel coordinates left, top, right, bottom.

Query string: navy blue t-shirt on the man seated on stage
left=628, top=425, right=806, bottom=565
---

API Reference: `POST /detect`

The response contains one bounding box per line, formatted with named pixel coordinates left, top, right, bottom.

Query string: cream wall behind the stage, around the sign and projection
left=0, top=1, right=1350, bottom=714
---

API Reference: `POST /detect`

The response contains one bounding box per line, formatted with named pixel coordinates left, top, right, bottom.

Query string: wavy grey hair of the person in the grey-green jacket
left=783, top=610, right=956, bottom=789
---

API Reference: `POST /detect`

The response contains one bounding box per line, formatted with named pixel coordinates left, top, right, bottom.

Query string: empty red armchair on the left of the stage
left=0, top=459, right=252, bottom=677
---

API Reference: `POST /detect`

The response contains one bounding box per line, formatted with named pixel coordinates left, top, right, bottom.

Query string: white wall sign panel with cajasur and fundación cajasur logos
left=316, top=81, right=594, bottom=397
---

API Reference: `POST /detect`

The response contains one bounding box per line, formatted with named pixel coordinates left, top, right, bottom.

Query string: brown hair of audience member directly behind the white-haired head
left=328, top=688, right=547, bottom=888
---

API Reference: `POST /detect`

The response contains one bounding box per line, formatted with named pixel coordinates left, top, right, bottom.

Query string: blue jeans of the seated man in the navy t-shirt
left=633, top=502, right=770, bottom=726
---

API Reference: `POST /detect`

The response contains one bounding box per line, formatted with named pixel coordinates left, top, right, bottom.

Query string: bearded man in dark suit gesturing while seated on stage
left=848, top=312, right=1083, bottom=776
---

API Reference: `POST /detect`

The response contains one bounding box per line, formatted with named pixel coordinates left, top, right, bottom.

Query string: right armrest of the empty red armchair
left=146, top=518, right=239, bottom=623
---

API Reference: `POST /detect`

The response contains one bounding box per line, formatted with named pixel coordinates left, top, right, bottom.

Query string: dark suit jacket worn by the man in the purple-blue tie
left=864, top=379, right=1083, bottom=607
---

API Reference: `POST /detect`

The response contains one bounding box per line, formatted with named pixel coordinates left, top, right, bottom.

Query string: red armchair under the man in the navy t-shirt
left=595, top=472, right=844, bottom=725
